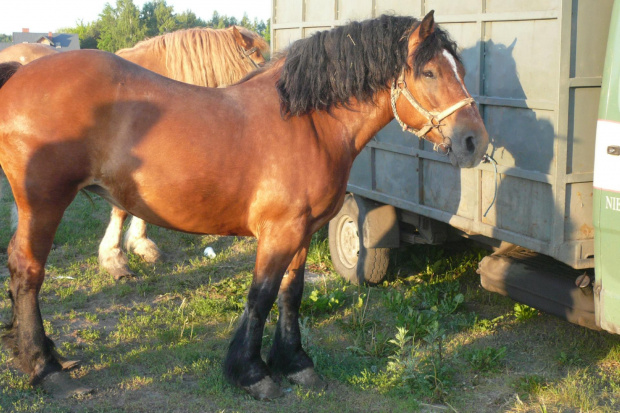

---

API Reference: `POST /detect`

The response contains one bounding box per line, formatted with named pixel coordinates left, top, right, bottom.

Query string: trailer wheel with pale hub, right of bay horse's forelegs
left=329, top=194, right=390, bottom=285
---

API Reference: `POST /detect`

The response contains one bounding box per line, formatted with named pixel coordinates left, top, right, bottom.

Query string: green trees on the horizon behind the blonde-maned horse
left=19, top=0, right=271, bottom=52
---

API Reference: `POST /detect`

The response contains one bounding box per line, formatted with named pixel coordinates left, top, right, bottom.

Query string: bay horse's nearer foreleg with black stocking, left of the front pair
left=224, top=222, right=304, bottom=400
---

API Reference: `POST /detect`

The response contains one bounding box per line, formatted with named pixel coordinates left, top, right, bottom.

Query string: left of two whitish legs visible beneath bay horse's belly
left=99, top=206, right=133, bottom=280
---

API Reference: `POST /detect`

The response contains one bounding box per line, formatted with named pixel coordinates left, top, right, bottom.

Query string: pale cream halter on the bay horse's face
left=390, top=69, right=475, bottom=156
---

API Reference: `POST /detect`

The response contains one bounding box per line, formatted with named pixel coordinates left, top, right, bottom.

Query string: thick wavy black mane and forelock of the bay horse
left=276, top=15, right=459, bottom=116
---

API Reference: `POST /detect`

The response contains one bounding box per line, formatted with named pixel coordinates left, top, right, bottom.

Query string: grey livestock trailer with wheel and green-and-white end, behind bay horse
left=272, top=0, right=620, bottom=333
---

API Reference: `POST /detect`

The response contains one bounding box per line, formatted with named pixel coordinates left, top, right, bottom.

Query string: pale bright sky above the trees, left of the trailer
left=0, top=0, right=271, bottom=34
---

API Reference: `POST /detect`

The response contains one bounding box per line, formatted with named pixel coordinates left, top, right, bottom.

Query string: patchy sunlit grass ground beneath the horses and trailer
left=0, top=175, right=620, bottom=412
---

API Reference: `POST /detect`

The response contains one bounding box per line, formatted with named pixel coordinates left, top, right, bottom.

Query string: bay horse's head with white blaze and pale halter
left=391, top=11, right=489, bottom=168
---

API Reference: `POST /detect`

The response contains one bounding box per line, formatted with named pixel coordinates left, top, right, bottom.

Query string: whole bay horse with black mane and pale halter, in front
left=0, top=13, right=488, bottom=399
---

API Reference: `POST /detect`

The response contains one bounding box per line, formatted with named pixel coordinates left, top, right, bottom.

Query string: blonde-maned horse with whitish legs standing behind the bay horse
left=99, top=26, right=269, bottom=280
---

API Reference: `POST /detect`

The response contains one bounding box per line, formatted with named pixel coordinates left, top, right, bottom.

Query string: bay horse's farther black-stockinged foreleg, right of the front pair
left=267, top=237, right=327, bottom=390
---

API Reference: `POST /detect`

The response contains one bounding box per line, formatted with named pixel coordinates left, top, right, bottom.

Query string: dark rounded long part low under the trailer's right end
left=478, top=248, right=600, bottom=330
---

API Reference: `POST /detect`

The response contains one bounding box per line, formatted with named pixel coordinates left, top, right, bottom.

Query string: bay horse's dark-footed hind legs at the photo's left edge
left=2, top=192, right=90, bottom=397
